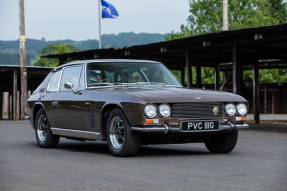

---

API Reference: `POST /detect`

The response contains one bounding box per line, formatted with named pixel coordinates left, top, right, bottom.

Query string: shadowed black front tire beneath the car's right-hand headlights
left=205, top=130, right=238, bottom=153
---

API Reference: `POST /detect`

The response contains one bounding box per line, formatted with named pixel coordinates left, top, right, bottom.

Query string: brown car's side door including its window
left=53, top=65, right=87, bottom=131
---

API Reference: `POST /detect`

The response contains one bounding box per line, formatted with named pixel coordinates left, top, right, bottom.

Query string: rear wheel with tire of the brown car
left=35, top=108, right=60, bottom=148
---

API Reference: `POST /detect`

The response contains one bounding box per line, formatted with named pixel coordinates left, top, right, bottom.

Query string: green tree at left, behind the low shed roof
left=34, top=43, right=81, bottom=67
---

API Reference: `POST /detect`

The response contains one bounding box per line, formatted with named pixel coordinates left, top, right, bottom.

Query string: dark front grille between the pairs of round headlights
left=170, top=102, right=223, bottom=118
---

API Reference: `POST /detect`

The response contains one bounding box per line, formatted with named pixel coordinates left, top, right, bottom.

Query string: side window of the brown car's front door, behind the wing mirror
left=60, top=66, right=82, bottom=91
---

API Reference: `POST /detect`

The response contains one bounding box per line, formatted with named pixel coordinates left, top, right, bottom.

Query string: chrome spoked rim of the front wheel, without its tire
left=110, top=116, right=125, bottom=150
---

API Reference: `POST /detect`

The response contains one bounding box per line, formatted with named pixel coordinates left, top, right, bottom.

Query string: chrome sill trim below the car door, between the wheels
left=51, top=127, right=103, bottom=140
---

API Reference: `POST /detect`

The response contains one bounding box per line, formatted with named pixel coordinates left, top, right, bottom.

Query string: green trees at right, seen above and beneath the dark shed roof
left=165, top=0, right=287, bottom=83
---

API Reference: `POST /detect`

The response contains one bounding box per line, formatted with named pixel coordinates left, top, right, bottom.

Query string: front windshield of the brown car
left=86, top=62, right=182, bottom=87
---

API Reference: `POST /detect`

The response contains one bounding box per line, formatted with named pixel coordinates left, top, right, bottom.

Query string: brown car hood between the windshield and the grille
left=105, top=87, right=247, bottom=103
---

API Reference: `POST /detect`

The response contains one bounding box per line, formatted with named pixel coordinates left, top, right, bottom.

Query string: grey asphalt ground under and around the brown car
left=0, top=121, right=287, bottom=191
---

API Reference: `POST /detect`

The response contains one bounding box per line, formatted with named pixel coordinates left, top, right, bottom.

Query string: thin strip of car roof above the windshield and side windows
left=53, top=59, right=161, bottom=71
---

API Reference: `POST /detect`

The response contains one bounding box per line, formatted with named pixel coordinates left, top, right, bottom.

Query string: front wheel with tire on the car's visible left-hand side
left=106, top=108, right=140, bottom=157
